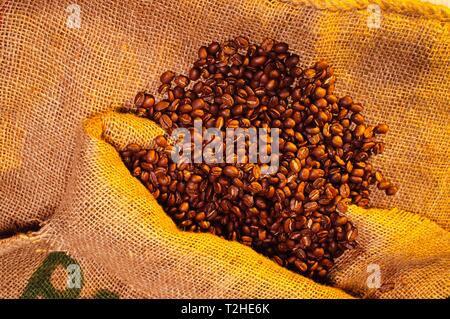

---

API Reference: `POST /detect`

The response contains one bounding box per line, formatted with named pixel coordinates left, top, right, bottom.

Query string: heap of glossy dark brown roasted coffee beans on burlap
left=121, top=36, right=397, bottom=279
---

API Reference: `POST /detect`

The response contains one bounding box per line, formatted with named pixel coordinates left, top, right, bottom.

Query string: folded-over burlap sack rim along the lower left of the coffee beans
left=40, top=113, right=354, bottom=298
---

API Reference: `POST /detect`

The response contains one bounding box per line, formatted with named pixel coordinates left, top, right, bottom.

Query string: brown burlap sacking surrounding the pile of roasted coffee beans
left=0, top=0, right=450, bottom=298
